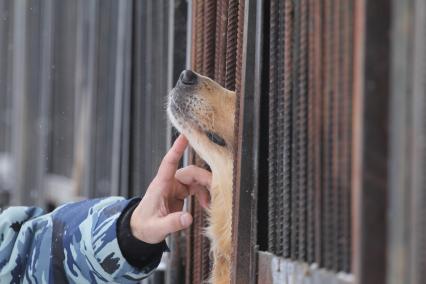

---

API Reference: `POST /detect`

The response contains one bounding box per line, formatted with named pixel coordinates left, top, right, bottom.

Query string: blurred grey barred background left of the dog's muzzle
left=0, top=0, right=187, bottom=208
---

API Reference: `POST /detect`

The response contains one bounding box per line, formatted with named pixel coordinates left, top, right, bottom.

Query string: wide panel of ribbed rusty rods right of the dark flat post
left=268, top=0, right=354, bottom=272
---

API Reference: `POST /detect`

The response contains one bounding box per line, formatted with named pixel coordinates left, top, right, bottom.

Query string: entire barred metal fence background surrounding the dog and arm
left=0, top=0, right=426, bottom=284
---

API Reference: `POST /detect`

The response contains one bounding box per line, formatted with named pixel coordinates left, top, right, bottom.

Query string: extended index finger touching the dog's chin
left=157, top=134, right=188, bottom=180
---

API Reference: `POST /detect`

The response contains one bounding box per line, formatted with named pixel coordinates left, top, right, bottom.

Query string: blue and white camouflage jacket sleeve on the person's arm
left=0, top=197, right=159, bottom=283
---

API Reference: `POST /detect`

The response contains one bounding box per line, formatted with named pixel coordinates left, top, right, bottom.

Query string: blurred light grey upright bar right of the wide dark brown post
left=386, top=0, right=415, bottom=284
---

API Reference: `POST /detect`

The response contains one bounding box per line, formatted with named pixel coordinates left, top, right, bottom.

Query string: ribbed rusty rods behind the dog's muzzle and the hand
left=186, top=0, right=244, bottom=283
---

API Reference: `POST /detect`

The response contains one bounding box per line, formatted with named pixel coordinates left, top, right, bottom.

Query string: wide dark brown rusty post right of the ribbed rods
left=353, top=0, right=390, bottom=284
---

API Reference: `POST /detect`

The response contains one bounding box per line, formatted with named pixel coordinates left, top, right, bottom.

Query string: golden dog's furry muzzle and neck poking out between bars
left=167, top=70, right=235, bottom=284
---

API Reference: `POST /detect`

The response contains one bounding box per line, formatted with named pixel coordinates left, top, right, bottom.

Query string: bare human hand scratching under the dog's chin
left=130, top=135, right=211, bottom=244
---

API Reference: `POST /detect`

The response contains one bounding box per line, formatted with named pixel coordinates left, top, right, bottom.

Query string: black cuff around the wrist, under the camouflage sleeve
left=117, top=198, right=169, bottom=269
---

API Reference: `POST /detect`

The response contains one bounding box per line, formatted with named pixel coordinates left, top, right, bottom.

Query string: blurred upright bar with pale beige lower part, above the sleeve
left=73, top=0, right=98, bottom=197
